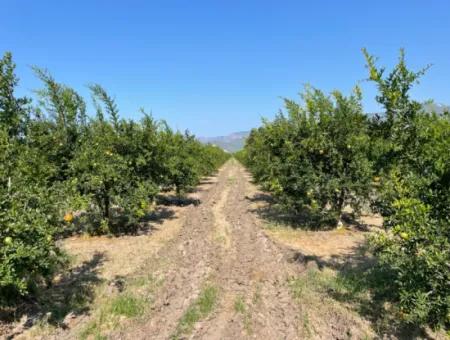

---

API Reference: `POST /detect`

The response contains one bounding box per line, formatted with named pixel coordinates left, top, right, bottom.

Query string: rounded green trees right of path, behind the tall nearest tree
left=244, top=87, right=372, bottom=223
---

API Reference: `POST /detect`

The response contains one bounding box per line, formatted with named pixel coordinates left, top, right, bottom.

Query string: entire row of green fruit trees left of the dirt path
left=0, top=53, right=228, bottom=304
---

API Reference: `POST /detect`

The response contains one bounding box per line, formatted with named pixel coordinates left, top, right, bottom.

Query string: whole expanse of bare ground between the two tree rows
left=7, top=160, right=440, bottom=339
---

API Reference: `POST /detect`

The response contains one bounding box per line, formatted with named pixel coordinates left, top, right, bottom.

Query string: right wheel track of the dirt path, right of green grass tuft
left=193, top=163, right=299, bottom=339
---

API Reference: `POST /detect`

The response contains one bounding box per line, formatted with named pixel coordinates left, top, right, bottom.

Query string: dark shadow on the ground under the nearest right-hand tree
left=286, top=243, right=433, bottom=339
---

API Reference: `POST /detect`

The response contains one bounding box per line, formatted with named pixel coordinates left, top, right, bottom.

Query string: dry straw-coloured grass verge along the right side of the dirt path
left=258, top=223, right=376, bottom=339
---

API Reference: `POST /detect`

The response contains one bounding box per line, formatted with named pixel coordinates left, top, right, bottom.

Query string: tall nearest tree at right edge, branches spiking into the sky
left=365, top=52, right=450, bottom=327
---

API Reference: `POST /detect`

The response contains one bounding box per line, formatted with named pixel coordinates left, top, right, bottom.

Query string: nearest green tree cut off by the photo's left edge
left=0, top=53, right=62, bottom=304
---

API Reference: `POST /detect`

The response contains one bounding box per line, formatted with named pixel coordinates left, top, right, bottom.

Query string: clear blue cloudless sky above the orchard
left=0, top=0, right=450, bottom=136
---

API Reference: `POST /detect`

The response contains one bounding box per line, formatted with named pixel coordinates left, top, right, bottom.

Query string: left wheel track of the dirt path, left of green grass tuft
left=114, top=163, right=236, bottom=339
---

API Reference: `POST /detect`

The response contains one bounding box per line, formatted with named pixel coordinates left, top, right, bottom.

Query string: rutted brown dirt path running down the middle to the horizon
left=116, top=160, right=299, bottom=339
